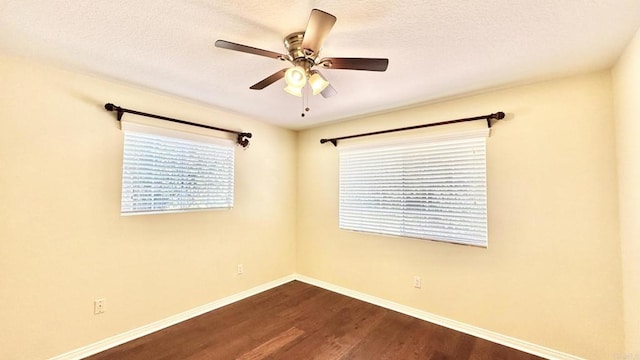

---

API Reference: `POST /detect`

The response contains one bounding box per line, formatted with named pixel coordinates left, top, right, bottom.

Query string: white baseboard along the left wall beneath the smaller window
left=50, top=274, right=295, bottom=360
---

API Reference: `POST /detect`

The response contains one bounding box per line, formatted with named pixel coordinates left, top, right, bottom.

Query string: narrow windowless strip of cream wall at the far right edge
left=612, top=27, right=640, bottom=358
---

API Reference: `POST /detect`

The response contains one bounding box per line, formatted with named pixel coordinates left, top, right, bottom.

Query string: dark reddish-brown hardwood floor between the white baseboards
left=87, top=281, right=540, bottom=360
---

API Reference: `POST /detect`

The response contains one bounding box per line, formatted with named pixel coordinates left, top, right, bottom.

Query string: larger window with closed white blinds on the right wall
left=340, top=129, right=488, bottom=247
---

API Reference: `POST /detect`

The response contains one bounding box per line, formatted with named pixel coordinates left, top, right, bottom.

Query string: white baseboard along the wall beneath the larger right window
left=295, top=274, right=584, bottom=360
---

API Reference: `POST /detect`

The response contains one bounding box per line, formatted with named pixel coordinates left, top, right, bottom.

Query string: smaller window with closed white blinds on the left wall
left=121, top=122, right=235, bottom=215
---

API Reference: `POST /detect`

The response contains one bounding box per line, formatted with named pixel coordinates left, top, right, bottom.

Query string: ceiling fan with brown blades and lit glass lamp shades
left=215, top=9, right=389, bottom=98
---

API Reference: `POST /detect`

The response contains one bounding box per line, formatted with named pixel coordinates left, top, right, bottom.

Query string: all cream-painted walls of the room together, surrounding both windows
left=0, top=52, right=640, bottom=359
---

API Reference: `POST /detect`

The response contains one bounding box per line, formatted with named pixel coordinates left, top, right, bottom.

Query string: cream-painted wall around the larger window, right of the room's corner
left=297, top=72, right=623, bottom=359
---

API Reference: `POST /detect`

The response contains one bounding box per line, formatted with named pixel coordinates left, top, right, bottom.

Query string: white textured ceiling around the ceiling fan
left=0, top=0, right=640, bottom=129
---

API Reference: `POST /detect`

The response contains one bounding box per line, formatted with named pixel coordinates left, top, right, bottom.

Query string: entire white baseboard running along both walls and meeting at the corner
left=50, top=274, right=584, bottom=360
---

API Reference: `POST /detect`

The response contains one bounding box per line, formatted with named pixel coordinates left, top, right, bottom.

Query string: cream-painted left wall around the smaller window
left=0, top=56, right=297, bottom=359
